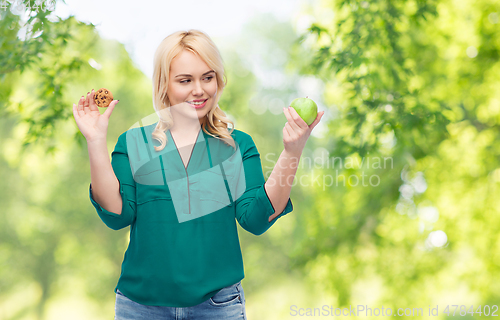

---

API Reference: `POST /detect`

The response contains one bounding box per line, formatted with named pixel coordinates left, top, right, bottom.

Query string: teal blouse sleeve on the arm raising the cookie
left=89, top=132, right=137, bottom=230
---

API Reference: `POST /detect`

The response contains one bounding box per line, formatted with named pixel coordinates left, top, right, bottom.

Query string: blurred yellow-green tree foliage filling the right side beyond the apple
left=290, top=0, right=500, bottom=310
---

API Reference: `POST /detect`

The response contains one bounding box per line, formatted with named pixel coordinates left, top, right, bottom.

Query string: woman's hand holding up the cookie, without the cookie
left=73, top=89, right=118, bottom=143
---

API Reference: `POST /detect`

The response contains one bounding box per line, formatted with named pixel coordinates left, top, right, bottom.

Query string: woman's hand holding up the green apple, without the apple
left=283, top=107, right=325, bottom=157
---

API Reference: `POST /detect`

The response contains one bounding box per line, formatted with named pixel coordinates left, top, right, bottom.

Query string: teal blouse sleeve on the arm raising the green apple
left=235, top=135, right=293, bottom=235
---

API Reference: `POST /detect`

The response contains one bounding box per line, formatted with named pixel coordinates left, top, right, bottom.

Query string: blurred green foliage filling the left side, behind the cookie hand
left=0, top=2, right=153, bottom=319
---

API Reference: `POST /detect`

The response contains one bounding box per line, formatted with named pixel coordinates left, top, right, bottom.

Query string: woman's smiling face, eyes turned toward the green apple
left=167, top=50, right=217, bottom=119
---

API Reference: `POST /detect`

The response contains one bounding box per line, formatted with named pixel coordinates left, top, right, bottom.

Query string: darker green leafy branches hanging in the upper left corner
left=0, top=0, right=97, bottom=153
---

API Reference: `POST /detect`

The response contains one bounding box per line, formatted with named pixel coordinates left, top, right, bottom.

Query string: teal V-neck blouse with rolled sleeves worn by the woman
left=89, top=124, right=293, bottom=307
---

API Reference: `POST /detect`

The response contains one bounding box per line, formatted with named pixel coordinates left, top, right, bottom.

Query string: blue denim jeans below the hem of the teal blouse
left=115, top=281, right=247, bottom=320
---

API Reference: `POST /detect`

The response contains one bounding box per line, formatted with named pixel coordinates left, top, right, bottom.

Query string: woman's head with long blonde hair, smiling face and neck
left=152, top=30, right=234, bottom=151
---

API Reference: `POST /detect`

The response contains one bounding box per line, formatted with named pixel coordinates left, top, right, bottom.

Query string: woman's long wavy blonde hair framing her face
left=152, top=29, right=235, bottom=151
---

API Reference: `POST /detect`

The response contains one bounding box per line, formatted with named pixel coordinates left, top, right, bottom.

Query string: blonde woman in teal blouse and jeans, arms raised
left=73, top=30, right=323, bottom=319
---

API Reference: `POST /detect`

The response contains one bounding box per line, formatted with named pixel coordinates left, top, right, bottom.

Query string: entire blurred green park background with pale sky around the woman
left=0, top=0, right=500, bottom=320
